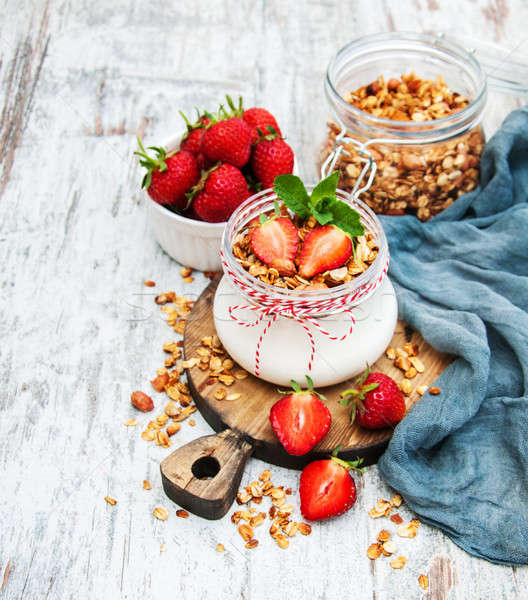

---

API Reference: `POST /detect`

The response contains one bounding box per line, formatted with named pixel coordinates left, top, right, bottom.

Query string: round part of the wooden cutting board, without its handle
left=183, top=279, right=452, bottom=469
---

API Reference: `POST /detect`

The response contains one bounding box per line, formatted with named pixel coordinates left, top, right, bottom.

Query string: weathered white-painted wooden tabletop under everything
left=0, top=0, right=528, bottom=600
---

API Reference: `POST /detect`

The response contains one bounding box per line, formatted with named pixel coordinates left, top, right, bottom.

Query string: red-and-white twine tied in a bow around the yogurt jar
left=220, top=252, right=389, bottom=376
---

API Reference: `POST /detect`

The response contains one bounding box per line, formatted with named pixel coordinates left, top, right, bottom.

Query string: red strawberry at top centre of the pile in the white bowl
left=200, top=117, right=251, bottom=167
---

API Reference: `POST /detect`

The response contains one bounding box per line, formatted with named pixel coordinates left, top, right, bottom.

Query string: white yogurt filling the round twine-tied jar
left=213, top=276, right=398, bottom=387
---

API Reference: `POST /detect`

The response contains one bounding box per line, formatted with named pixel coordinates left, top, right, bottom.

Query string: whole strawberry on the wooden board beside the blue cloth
left=341, top=368, right=405, bottom=429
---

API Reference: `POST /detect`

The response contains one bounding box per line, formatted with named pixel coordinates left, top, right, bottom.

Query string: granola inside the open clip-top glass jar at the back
left=321, top=73, right=484, bottom=221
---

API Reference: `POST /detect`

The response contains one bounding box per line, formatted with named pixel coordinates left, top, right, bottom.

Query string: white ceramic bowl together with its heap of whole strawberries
left=135, top=96, right=294, bottom=271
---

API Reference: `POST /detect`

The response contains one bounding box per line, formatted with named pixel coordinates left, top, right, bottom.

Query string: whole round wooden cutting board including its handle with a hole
left=161, top=280, right=452, bottom=519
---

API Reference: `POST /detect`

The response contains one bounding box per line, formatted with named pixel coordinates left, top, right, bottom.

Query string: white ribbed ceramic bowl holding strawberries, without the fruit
left=145, top=130, right=226, bottom=271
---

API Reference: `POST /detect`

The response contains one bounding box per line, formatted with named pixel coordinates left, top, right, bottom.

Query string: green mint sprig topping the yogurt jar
left=273, top=171, right=365, bottom=239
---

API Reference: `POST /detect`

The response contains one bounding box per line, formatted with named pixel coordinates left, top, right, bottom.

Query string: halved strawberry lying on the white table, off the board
left=299, top=448, right=363, bottom=521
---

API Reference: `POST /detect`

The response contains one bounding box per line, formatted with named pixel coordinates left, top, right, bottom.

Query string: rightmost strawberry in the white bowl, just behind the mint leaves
left=250, top=133, right=294, bottom=189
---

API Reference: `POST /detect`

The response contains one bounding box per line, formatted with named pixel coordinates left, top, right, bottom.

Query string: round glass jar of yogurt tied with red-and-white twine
left=213, top=190, right=398, bottom=386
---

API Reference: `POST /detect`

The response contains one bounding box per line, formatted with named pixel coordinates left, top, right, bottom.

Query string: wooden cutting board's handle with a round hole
left=160, top=429, right=253, bottom=519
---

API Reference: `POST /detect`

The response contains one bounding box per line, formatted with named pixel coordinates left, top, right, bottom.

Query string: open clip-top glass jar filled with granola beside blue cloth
left=320, top=33, right=487, bottom=221
